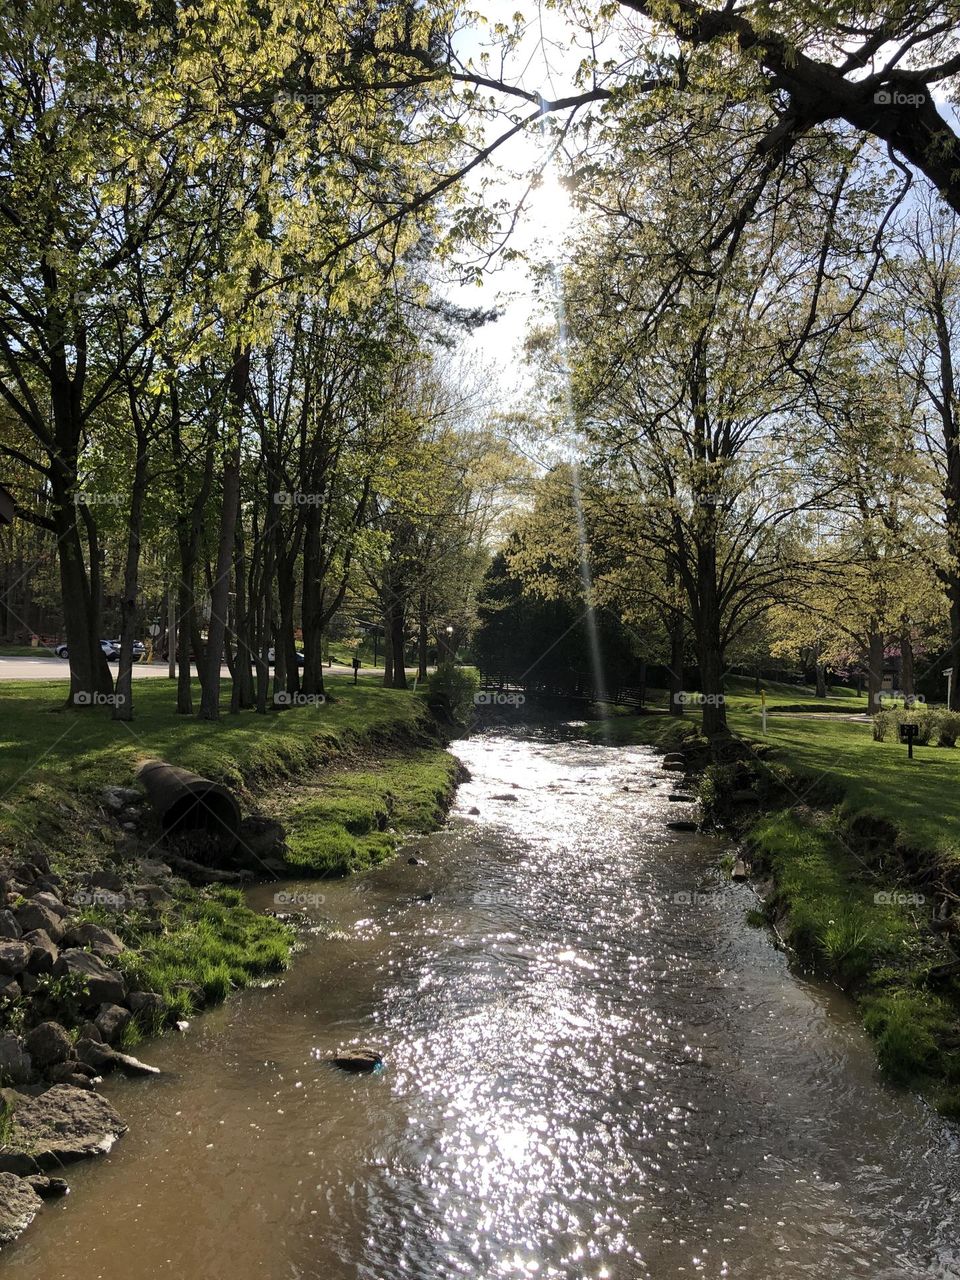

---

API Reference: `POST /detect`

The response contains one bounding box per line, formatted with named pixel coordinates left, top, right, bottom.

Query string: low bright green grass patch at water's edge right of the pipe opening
left=276, top=749, right=458, bottom=876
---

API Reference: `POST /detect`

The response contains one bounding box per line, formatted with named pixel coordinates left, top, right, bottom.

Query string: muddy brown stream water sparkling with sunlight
left=0, top=728, right=960, bottom=1280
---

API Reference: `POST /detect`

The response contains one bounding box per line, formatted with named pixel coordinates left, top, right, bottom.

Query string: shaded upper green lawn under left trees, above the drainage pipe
left=0, top=676, right=428, bottom=847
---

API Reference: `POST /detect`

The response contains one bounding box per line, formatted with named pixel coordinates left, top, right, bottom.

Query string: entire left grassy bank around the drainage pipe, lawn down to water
left=0, top=677, right=457, bottom=1044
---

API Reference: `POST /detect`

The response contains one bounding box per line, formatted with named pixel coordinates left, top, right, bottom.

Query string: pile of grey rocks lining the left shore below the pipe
left=0, top=742, right=456, bottom=1249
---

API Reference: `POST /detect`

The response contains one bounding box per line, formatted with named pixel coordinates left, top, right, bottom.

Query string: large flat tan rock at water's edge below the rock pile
left=5, top=1084, right=127, bottom=1174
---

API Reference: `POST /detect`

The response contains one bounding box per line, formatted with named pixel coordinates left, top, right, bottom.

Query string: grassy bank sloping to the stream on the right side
left=590, top=682, right=960, bottom=1116
